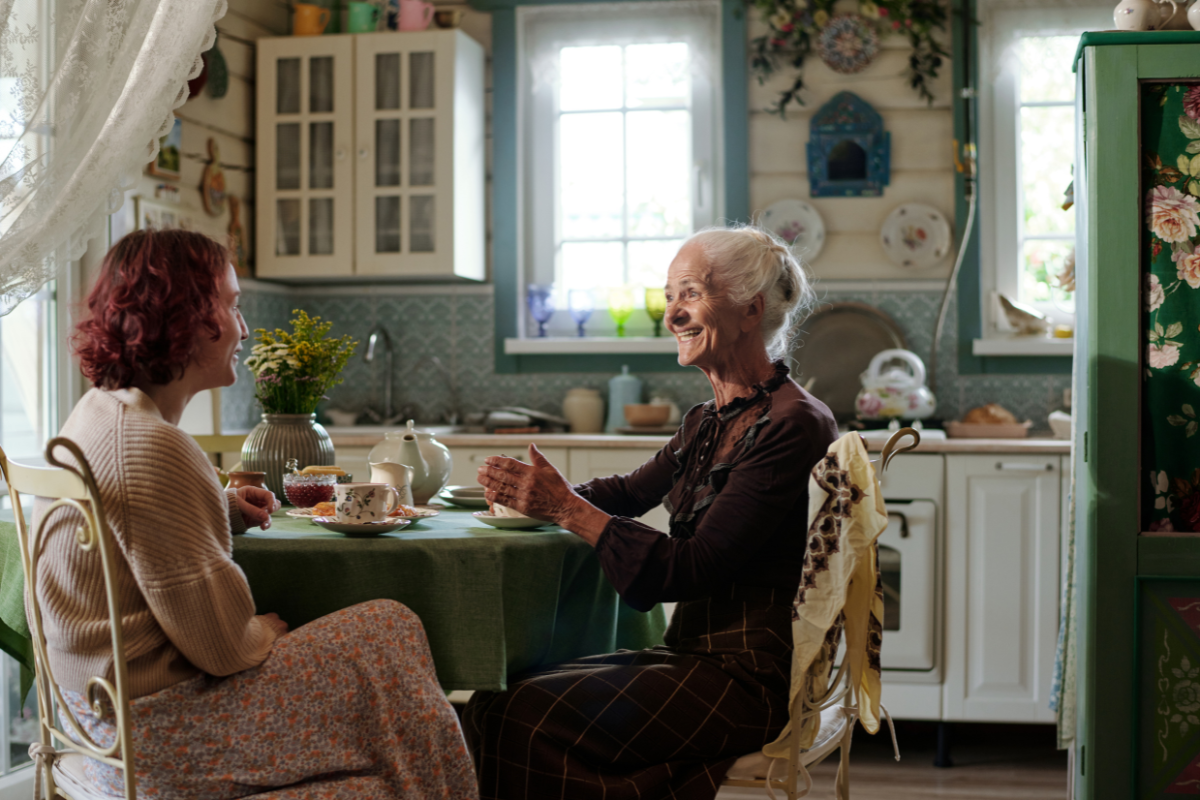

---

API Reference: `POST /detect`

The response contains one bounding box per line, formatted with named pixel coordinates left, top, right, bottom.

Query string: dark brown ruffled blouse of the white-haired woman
left=575, top=362, right=838, bottom=610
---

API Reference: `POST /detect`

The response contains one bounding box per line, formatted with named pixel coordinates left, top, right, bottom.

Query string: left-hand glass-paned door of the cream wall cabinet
left=254, top=36, right=354, bottom=278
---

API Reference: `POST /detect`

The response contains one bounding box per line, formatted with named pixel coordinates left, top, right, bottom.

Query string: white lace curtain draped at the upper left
left=0, top=0, right=226, bottom=315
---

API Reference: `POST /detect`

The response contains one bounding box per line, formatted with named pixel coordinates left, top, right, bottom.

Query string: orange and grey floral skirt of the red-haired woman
left=57, top=600, right=478, bottom=800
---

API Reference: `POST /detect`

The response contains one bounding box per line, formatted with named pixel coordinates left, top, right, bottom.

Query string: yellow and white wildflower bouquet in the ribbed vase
left=246, top=308, right=359, bottom=414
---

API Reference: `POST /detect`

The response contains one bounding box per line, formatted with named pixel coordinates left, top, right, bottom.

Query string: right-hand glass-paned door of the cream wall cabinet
left=355, top=34, right=454, bottom=275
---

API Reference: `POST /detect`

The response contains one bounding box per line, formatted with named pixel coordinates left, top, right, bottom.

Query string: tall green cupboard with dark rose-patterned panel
left=1073, top=31, right=1200, bottom=800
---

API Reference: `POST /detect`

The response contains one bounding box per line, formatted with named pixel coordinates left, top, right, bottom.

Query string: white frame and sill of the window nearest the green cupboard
left=972, top=4, right=1112, bottom=355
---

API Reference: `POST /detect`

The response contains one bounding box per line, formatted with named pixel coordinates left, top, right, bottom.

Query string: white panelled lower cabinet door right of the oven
left=943, top=455, right=1061, bottom=722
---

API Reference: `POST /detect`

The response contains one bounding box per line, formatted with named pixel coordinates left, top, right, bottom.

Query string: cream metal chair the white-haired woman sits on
left=716, top=428, right=920, bottom=800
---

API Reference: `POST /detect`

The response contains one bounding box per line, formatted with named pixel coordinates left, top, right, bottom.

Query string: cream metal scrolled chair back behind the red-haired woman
left=0, top=437, right=137, bottom=800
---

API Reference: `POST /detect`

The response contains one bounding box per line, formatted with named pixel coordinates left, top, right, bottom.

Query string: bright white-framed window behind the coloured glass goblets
left=518, top=0, right=721, bottom=337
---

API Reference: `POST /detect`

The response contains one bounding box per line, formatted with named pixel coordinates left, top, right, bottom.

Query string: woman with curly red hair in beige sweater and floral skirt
left=40, top=231, right=476, bottom=800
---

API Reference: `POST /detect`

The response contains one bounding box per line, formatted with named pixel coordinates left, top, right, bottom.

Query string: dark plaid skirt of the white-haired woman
left=463, top=587, right=794, bottom=800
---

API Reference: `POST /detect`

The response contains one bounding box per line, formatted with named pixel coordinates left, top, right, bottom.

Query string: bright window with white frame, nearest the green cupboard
left=979, top=1, right=1112, bottom=337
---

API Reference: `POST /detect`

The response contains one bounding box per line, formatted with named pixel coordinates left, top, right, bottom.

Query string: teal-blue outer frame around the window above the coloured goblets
left=473, top=0, right=750, bottom=374
